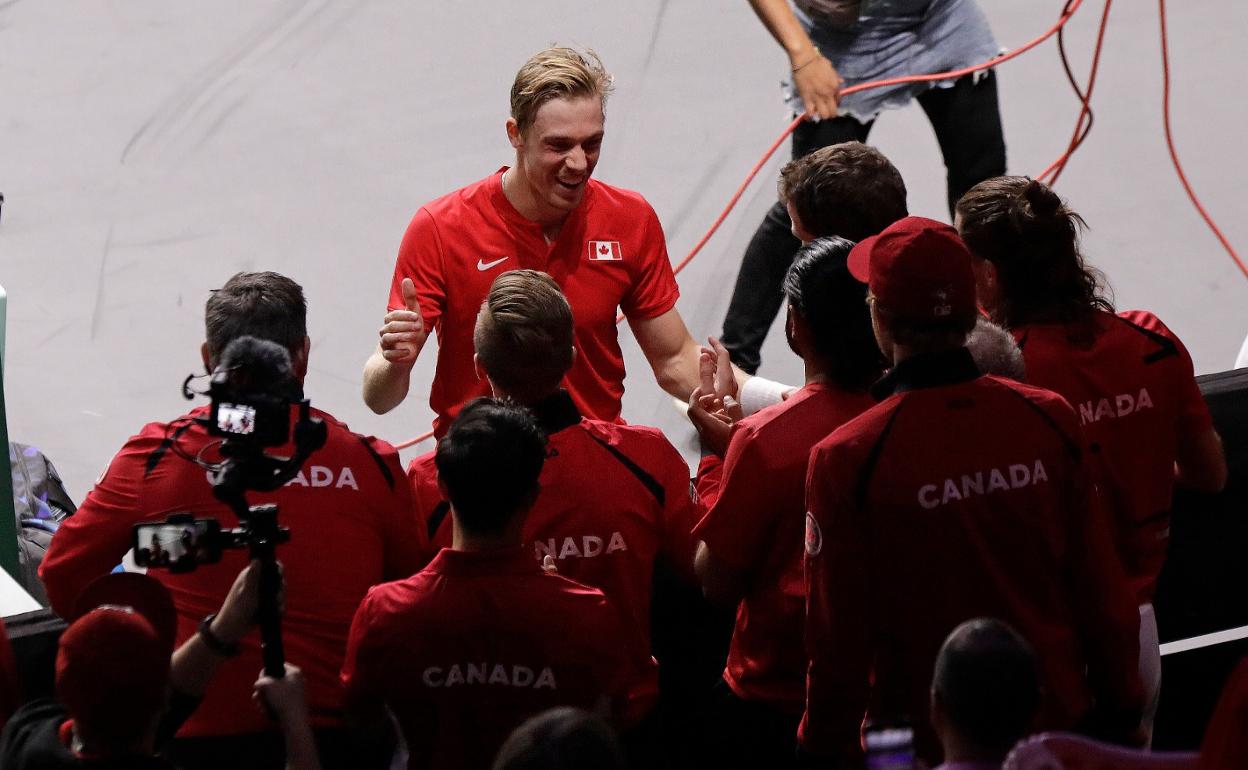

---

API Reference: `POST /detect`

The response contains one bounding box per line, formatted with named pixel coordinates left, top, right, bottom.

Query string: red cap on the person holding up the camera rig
left=56, top=573, right=177, bottom=741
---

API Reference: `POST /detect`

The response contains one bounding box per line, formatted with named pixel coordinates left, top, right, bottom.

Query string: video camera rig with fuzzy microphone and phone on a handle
left=134, top=336, right=328, bottom=678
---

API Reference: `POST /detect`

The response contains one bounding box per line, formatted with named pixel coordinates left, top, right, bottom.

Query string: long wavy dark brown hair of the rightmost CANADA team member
left=953, top=176, right=1113, bottom=328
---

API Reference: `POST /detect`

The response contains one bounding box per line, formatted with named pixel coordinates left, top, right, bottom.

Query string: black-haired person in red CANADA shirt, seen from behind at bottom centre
left=342, top=398, right=653, bottom=769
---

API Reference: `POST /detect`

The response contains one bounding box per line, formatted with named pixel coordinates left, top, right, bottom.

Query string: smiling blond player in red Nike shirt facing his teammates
left=364, top=47, right=713, bottom=436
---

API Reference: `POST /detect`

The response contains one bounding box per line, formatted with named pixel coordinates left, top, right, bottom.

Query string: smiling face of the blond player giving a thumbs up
left=507, top=96, right=603, bottom=223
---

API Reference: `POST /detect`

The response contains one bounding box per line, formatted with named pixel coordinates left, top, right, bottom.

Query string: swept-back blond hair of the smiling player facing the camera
left=512, top=46, right=613, bottom=132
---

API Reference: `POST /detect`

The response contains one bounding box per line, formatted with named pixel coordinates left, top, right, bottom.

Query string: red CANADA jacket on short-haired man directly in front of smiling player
left=408, top=392, right=703, bottom=658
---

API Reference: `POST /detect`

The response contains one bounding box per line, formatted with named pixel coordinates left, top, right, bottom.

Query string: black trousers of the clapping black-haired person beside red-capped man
left=695, top=679, right=801, bottom=770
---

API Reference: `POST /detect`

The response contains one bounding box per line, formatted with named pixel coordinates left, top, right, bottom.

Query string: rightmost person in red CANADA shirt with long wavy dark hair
left=957, top=176, right=1227, bottom=730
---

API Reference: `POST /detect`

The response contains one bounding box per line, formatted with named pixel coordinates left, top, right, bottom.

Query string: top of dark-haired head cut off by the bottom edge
left=493, top=706, right=628, bottom=770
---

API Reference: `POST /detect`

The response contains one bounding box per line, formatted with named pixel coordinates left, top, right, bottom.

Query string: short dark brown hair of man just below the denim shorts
left=780, top=142, right=907, bottom=241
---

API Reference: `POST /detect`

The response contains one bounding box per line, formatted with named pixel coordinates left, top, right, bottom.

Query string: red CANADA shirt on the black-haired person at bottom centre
left=342, top=548, right=648, bottom=769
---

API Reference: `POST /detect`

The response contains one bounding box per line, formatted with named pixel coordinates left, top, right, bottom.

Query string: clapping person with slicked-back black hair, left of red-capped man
left=694, top=237, right=884, bottom=768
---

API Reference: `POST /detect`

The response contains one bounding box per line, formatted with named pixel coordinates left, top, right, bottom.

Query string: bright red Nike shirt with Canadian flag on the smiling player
left=389, top=168, right=679, bottom=436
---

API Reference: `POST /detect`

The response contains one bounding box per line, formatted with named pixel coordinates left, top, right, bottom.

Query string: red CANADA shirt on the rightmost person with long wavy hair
left=1015, top=311, right=1213, bottom=603
